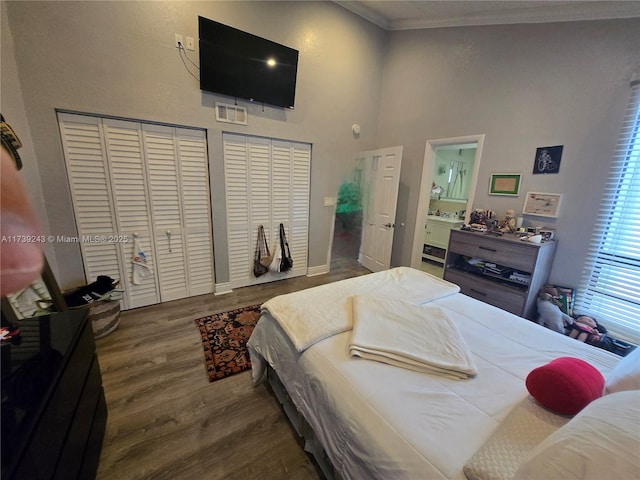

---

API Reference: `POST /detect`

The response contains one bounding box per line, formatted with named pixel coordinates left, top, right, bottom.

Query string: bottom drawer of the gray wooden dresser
left=444, top=268, right=527, bottom=315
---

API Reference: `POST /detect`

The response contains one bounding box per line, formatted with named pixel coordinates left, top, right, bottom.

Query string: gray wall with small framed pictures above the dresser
left=378, top=19, right=640, bottom=287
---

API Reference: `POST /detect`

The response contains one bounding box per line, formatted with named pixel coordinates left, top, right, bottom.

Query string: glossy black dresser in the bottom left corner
left=2, top=310, right=107, bottom=480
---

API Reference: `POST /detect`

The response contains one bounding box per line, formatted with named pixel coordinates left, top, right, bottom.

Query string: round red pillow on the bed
left=526, top=357, right=604, bottom=415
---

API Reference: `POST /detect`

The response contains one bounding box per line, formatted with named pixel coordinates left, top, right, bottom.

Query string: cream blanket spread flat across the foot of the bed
left=262, top=267, right=460, bottom=352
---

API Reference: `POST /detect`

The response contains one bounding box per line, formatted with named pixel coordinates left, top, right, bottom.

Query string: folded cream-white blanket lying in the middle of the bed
left=349, top=295, right=478, bottom=379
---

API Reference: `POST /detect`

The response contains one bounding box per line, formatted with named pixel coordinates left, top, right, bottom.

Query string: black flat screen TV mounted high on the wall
left=198, top=16, right=298, bottom=108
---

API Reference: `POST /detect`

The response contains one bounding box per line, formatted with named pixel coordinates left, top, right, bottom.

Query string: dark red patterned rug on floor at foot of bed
left=195, top=305, right=260, bottom=382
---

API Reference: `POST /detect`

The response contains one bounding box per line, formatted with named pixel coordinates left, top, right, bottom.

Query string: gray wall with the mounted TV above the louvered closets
left=2, top=1, right=387, bottom=288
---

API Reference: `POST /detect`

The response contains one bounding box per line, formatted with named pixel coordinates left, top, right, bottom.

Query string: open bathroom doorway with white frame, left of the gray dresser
left=411, top=134, right=484, bottom=273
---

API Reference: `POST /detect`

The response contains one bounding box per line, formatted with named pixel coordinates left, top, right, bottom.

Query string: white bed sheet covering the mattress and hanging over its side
left=248, top=293, right=619, bottom=480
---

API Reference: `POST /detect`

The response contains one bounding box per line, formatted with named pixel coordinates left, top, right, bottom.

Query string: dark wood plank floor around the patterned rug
left=96, top=258, right=369, bottom=480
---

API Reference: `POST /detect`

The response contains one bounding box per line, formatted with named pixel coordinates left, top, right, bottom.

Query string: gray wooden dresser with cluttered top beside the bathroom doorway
left=444, top=230, right=557, bottom=320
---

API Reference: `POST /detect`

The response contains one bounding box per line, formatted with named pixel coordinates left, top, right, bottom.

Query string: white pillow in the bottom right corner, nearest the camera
left=513, top=390, right=640, bottom=480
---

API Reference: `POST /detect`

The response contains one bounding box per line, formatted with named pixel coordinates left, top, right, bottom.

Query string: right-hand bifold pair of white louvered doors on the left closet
left=142, top=125, right=213, bottom=301
